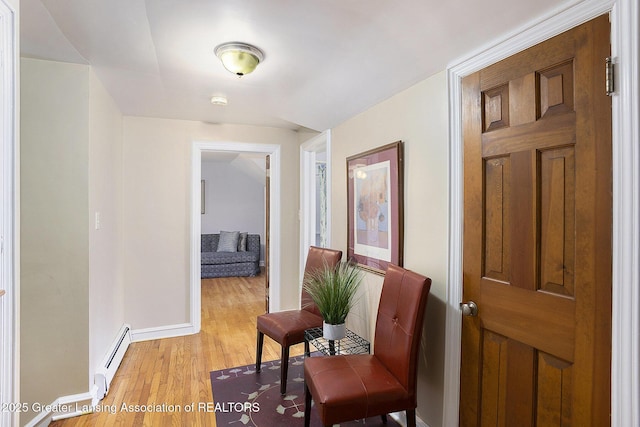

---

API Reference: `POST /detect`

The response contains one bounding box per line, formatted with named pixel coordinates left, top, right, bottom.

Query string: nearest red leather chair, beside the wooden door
left=304, top=265, right=431, bottom=427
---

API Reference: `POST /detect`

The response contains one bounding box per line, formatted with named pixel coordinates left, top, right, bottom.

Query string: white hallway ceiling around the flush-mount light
left=20, top=0, right=564, bottom=131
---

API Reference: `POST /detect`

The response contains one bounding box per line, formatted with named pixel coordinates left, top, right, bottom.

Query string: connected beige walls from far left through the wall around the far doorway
left=20, top=58, right=299, bottom=422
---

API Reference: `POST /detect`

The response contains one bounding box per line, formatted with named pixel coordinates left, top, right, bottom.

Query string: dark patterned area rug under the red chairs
left=211, top=356, right=399, bottom=427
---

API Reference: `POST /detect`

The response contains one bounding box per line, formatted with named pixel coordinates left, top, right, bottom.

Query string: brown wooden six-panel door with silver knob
left=460, top=16, right=612, bottom=427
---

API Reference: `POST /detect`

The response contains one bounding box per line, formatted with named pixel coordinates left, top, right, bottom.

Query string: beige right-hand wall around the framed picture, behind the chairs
left=331, top=72, right=449, bottom=426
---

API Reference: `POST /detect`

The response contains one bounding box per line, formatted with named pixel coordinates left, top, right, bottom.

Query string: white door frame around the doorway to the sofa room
left=190, top=141, right=281, bottom=333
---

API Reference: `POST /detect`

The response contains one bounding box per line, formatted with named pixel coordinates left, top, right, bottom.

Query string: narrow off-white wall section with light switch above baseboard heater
left=88, top=71, right=125, bottom=384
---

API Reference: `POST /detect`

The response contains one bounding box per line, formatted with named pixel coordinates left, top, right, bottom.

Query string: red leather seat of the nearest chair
left=304, top=354, right=416, bottom=425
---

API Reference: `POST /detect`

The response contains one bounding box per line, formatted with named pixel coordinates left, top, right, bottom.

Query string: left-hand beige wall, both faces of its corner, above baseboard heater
left=20, top=58, right=124, bottom=422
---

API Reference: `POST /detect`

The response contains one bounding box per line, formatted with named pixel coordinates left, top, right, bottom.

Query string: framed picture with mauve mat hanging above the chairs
left=347, top=141, right=404, bottom=274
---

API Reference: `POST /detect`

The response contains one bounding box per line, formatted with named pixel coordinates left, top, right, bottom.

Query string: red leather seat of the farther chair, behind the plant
left=256, top=310, right=322, bottom=347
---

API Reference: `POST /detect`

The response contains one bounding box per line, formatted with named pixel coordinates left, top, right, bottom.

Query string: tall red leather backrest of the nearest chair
left=373, top=264, right=431, bottom=399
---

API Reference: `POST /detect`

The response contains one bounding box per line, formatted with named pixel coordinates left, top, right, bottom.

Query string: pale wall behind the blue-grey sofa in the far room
left=201, top=155, right=266, bottom=261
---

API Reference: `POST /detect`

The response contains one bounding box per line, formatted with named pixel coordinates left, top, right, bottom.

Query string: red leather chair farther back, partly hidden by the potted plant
left=256, top=246, right=342, bottom=394
